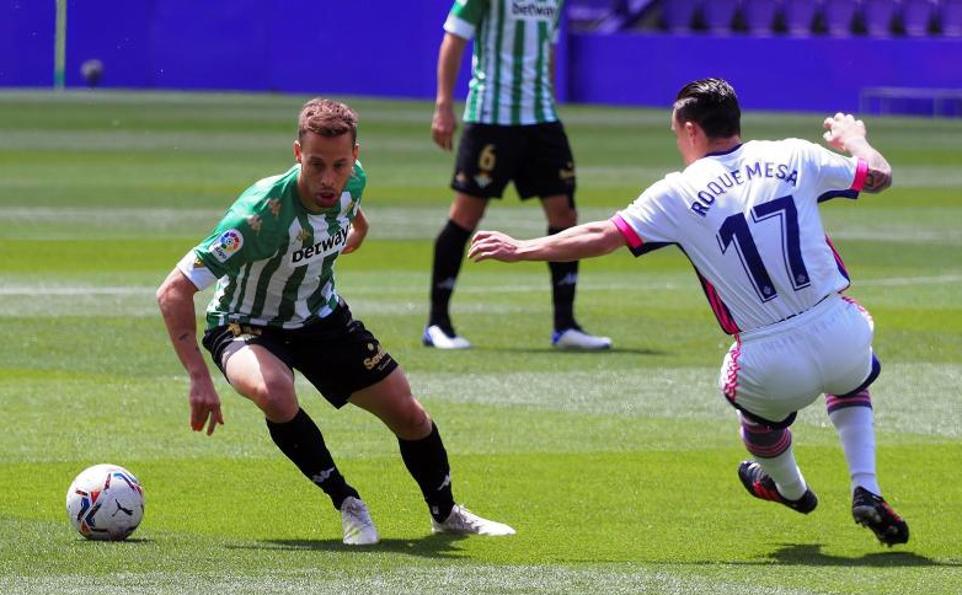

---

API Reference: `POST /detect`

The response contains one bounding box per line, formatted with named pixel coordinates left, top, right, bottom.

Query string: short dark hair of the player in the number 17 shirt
left=673, top=78, right=742, bottom=138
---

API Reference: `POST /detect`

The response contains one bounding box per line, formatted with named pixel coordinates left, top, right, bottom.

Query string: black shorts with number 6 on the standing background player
left=451, top=122, right=575, bottom=203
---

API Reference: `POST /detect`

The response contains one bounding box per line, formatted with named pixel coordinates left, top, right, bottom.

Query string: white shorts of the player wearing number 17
left=718, top=294, right=874, bottom=423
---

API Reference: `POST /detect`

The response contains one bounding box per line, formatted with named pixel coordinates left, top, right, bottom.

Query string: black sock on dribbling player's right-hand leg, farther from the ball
left=398, top=422, right=454, bottom=523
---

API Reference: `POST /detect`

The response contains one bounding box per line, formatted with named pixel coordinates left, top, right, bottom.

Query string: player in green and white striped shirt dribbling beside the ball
left=157, top=99, right=514, bottom=545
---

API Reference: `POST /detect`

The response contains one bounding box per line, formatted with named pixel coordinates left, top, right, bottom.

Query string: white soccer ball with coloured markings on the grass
left=67, top=465, right=144, bottom=541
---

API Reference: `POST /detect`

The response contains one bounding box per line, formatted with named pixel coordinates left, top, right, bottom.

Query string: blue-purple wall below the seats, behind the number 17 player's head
left=568, top=34, right=962, bottom=111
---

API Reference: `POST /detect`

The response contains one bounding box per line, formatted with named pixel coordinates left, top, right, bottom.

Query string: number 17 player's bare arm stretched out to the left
left=468, top=221, right=625, bottom=262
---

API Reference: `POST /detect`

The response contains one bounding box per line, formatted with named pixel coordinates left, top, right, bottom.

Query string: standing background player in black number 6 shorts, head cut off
left=423, top=0, right=611, bottom=349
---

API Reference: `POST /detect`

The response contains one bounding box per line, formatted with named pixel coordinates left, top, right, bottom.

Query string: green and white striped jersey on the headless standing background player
left=444, top=0, right=564, bottom=125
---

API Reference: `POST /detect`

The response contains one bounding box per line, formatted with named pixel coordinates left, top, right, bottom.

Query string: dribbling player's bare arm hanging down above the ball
left=157, top=268, right=224, bottom=436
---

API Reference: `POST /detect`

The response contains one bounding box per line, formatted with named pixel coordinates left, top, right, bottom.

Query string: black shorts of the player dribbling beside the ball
left=203, top=302, right=398, bottom=408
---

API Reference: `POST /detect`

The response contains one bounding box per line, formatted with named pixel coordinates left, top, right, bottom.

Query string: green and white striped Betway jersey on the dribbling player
left=188, top=162, right=367, bottom=328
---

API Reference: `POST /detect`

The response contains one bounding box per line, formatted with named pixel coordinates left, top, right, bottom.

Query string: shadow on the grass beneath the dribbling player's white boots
left=226, top=535, right=466, bottom=559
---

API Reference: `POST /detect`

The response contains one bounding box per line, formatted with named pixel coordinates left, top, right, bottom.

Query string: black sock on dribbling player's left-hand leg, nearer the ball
left=265, top=409, right=360, bottom=510
